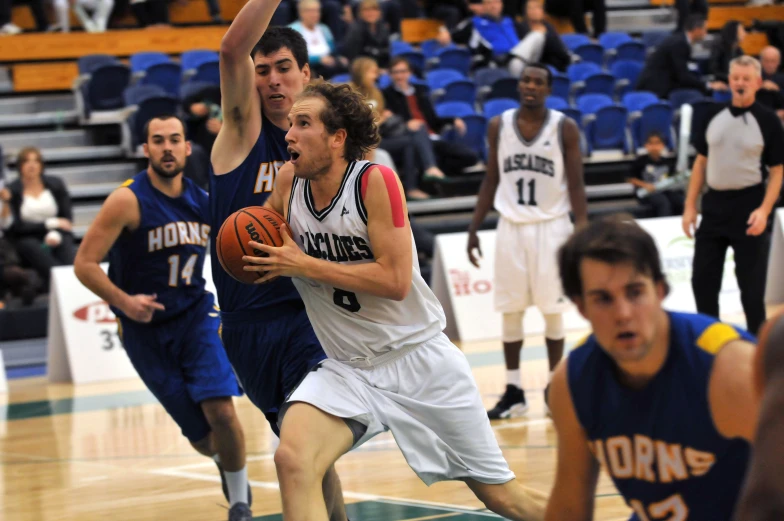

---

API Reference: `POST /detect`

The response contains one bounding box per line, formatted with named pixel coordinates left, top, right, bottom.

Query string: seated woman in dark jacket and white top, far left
left=8, top=147, right=76, bottom=289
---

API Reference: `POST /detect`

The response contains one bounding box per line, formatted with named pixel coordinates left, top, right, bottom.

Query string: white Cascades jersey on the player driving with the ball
left=288, top=161, right=446, bottom=361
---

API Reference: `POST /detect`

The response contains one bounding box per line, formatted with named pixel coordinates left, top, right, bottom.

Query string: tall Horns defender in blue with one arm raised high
left=210, top=0, right=346, bottom=521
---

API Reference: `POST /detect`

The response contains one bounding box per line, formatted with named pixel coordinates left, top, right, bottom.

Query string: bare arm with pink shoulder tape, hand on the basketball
left=243, top=167, right=413, bottom=300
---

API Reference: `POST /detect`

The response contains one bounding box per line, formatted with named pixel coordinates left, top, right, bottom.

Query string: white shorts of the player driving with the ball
left=280, top=333, right=515, bottom=486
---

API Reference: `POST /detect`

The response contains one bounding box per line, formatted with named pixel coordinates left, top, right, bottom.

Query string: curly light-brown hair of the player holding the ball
left=300, top=80, right=381, bottom=161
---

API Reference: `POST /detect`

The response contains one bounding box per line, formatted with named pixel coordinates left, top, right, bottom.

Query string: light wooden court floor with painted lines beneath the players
left=0, top=298, right=764, bottom=521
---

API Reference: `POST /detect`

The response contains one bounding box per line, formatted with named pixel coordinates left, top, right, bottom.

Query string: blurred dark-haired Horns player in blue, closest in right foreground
left=545, top=213, right=758, bottom=521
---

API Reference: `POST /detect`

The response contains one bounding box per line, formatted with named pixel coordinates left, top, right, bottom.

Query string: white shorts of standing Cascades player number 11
left=495, top=215, right=574, bottom=314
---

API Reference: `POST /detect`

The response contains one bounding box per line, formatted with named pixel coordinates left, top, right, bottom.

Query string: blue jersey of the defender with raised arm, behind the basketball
left=210, top=116, right=300, bottom=312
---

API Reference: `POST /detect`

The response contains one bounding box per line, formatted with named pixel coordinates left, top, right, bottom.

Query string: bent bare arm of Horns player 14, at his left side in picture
left=74, top=188, right=164, bottom=322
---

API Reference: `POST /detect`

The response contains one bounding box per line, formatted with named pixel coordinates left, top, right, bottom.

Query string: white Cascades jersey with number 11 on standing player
left=494, top=109, right=571, bottom=224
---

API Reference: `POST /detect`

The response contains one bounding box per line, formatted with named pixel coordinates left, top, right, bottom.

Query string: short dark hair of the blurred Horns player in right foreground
left=558, top=214, right=670, bottom=300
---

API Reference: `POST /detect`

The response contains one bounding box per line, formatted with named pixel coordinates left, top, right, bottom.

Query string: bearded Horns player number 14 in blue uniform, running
left=74, top=116, right=252, bottom=521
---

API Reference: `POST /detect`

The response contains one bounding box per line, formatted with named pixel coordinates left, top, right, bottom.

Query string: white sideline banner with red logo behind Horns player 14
left=47, top=255, right=215, bottom=384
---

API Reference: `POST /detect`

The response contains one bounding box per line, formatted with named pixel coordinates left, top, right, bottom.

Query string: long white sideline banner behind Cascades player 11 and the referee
left=432, top=217, right=744, bottom=342
